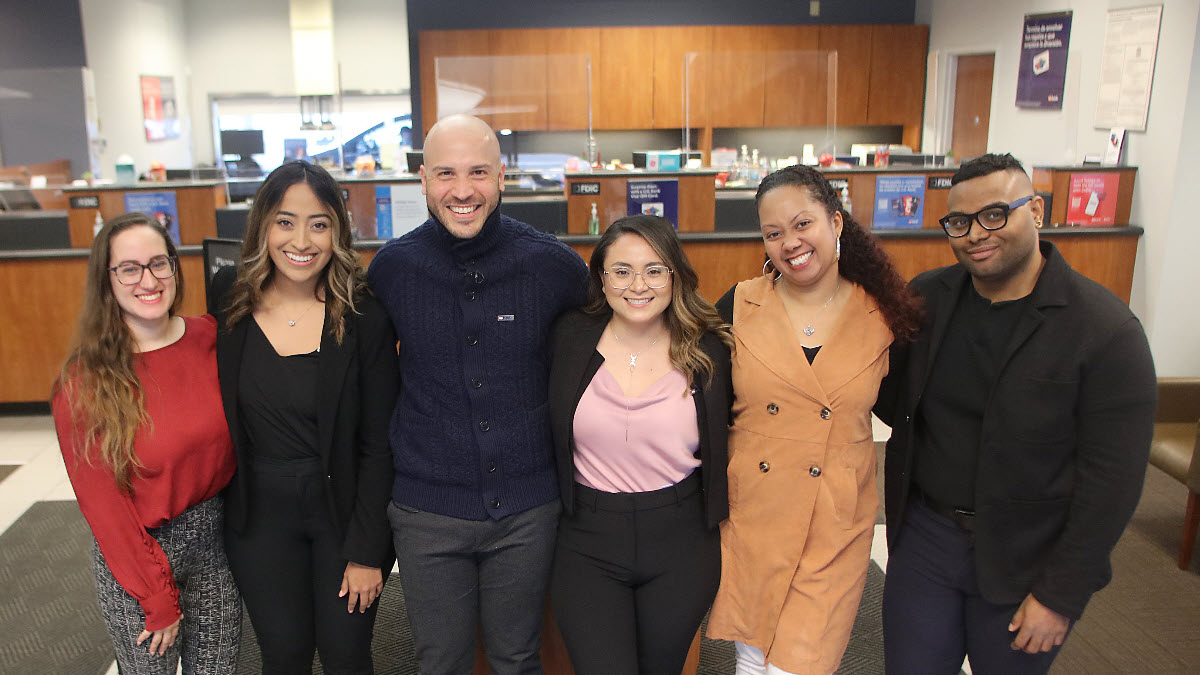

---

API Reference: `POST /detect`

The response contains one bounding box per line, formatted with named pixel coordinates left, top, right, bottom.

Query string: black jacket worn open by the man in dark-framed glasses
left=876, top=241, right=1157, bottom=619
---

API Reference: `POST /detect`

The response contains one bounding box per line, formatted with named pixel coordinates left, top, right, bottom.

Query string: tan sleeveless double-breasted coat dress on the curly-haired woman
left=708, top=276, right=892, bottom=674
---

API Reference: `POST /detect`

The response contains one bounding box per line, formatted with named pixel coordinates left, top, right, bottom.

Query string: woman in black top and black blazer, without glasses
left=211, top=162, right=398, bottom=674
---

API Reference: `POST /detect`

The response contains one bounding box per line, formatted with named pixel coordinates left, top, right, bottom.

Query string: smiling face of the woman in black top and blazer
left=266, top=183, right=335, bottom=288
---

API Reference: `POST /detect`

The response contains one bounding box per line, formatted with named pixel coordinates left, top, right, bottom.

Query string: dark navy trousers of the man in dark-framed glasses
left=883, top=501, right=1058, bottom=675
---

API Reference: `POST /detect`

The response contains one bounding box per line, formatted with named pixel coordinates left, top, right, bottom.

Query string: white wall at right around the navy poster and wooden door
left=917, top=0, right=1200, bottom=375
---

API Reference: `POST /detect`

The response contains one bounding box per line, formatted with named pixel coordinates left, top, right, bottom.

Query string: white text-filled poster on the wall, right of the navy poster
left=1096, top=5, right=1163, bottom=131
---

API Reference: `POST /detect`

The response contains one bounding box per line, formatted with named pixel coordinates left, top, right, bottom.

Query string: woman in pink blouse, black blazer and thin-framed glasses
left=550, top=215, right=731, bottom=675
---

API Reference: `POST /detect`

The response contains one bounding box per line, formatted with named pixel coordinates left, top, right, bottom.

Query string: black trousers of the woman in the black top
left=226, top=459, right=376, bottom=675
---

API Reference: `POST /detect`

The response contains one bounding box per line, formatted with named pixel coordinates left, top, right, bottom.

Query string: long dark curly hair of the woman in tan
left=755, top=166, right=922, bottom=341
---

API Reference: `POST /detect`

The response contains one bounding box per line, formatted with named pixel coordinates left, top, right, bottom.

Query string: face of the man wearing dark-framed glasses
left=949, top=171, right=1044, bottom=291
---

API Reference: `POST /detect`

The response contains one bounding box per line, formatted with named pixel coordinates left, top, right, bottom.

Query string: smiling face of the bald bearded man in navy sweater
left=421, top=115, right=504, bottom=239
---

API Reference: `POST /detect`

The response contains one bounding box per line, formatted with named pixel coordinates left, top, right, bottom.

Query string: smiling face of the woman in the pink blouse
left=601, top=234, right=674, bottom=324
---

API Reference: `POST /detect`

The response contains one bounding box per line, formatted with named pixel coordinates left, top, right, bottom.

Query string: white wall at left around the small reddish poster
left=79, top=0, right=193, bottom=178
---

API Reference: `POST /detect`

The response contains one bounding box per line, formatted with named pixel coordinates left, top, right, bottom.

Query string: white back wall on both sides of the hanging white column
left=186, top=0, right=409, bottom=163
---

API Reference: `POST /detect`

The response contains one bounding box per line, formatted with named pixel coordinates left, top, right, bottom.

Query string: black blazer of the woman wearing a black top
left=211, top=268, right=400, bottom=566
